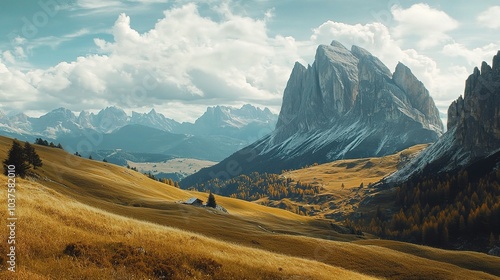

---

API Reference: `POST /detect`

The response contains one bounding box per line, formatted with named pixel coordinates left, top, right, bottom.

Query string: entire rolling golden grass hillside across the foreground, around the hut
left=0, top=137, right=500, bottom=279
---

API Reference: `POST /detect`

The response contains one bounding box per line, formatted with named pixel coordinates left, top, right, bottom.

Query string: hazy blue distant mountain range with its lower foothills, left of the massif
left=0, top=104, right=277, bottom=164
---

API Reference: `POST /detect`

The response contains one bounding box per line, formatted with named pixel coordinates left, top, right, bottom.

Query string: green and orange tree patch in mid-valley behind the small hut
left=191, top=172, right=320, bottom=201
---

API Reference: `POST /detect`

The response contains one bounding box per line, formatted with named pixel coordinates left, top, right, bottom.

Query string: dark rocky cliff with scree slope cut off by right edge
left=386, top=51, right=500, bottom=184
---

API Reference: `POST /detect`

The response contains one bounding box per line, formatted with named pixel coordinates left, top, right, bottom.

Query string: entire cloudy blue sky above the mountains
left=0, top=0, right=500, bottom=122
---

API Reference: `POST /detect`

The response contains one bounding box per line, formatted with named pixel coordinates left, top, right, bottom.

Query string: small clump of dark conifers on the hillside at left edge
left=3, top=140, right=42, bottom=178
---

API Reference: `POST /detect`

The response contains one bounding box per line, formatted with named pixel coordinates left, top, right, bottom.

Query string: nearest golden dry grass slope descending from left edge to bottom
left=0, top=175, right=376, bottom=279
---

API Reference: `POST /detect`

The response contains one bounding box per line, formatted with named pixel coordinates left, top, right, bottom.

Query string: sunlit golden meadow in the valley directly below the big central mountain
left=272, top=144, right=428, bottom=218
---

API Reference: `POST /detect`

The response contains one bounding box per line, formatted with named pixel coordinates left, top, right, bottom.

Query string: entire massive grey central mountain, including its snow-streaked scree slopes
left=183, top=41, right=443, bottom=186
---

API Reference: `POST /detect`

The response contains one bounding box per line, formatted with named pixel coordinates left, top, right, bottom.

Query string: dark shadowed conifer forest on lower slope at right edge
left=365, top=169, right=500, bottom=247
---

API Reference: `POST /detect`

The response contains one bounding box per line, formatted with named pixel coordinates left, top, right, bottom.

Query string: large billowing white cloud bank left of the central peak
left=2, top=1, right=299, bottom=117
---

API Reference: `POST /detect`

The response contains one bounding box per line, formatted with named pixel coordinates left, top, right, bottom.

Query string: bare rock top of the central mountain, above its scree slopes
left=274, top=41, right=443, bottom=138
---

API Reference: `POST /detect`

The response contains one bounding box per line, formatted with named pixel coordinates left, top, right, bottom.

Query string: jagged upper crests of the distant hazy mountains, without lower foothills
left=0, top=104, right=277, bottom=139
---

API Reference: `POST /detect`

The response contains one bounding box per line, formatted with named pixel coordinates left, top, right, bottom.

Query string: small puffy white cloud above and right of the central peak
left=391, top=3, right=459, bottom=49
